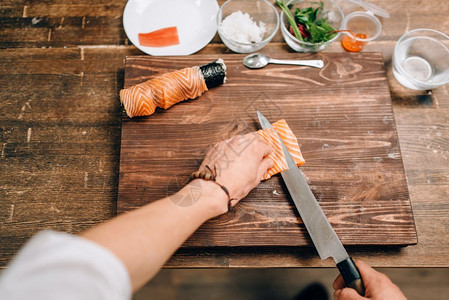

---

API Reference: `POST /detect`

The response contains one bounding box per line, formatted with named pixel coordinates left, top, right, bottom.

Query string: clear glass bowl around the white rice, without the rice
left=217, top=0, right=280, bottom=53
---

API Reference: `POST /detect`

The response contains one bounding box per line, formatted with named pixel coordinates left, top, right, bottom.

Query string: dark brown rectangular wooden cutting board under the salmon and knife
left=117, top=53, right=417, bottom=247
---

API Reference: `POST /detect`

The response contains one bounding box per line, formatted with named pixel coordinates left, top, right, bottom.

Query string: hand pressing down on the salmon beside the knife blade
left=199, top=132, right=273, bottom=206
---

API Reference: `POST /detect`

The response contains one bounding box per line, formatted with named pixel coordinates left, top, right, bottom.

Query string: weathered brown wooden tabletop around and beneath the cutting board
left=0, top=0, right=449, bottom=268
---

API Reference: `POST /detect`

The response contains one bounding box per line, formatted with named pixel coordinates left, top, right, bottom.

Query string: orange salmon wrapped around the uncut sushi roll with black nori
left=120, top=66, right=207, bottom=118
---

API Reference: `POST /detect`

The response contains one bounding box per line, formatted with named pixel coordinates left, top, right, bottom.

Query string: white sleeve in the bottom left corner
left=0, top=230, right=132, bottom=300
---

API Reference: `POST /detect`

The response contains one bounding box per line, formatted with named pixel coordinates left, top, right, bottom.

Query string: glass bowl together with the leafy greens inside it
left=276, top=0, right=344, bottom=52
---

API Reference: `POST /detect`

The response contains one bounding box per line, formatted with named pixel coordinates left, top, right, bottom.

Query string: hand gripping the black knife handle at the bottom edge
left=334, top=260, right=407, bottom=300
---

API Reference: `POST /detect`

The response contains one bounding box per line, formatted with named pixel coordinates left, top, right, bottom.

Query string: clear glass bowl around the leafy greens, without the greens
left=280, top=0, right=345, bottom=52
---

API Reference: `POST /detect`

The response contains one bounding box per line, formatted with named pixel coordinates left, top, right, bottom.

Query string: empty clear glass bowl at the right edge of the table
left=393, top=29, right=449, bottom=90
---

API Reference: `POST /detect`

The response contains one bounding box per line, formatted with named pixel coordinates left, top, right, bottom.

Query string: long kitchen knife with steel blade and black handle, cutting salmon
left=257, top=111, right=365, bottom=296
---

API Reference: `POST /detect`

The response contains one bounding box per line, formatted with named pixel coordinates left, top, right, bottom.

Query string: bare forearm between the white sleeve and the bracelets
left=81, top=180, right=227, bottom=291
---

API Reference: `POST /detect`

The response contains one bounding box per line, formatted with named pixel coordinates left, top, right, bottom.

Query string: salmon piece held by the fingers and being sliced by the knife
left=257, top=119, right=306, bottom=180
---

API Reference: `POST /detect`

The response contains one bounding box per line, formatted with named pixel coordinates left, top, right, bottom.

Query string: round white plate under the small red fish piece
left=123, top=0, right=219, bottom=55
